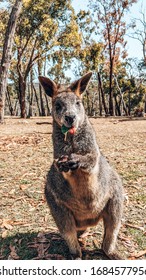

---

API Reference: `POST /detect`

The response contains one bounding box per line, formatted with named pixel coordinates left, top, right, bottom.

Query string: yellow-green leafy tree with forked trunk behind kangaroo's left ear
left=15, top=0, right=79, bottom=118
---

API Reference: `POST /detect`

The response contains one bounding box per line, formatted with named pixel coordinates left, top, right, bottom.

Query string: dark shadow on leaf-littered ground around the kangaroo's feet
left=0, top=232, right=108, bottom=260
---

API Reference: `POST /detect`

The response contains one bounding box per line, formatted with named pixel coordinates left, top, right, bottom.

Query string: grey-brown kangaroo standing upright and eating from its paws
left=39, top=72, right=123, bottom=259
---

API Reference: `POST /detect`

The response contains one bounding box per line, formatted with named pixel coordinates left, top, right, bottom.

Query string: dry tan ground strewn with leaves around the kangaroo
left=0, top=117, right=146, bottom=260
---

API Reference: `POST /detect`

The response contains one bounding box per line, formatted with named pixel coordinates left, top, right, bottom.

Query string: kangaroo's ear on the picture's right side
left=69, top=72, right=92, bottom=95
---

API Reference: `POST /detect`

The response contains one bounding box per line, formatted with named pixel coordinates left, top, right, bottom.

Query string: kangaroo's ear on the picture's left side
left=38, top=76, right=57, bottom=97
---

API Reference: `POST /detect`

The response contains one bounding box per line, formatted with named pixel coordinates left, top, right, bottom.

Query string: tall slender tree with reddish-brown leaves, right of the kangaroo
left=90, top=0, right=137, bottom=115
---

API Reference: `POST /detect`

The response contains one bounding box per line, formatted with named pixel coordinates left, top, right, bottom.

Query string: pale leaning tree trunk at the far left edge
left=0, top=0, right=22, bottom=123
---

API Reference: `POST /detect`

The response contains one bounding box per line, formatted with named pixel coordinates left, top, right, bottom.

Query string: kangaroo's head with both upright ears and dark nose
left=39, top=72, right=92, bottom=129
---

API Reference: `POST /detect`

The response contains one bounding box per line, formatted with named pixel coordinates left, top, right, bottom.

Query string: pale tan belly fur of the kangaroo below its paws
left=63, top=169, right=106, bottom=224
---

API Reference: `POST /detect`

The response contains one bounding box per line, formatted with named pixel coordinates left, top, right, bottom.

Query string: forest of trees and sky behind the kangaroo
left=0, top=0, right=146, bottom=122
